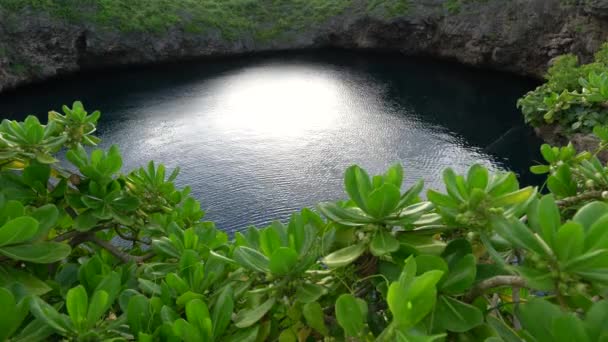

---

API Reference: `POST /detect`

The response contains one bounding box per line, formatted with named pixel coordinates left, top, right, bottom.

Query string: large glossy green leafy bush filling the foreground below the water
left=0, top=102, right=608, bottom=342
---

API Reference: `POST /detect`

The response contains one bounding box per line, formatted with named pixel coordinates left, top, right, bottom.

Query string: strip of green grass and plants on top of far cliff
left=0, top=0, right=498, bottom=40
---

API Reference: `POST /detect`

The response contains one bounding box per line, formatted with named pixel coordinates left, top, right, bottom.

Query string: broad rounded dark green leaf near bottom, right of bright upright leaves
left=433, top=296, right=483, bottom=333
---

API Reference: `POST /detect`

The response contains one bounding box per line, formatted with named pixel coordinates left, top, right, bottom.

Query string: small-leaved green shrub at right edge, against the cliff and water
left=518, top=44, right=608, bottom=135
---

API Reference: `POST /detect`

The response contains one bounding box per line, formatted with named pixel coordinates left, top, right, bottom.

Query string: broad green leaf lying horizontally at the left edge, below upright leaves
left=0, top=242, right=72, bottom=264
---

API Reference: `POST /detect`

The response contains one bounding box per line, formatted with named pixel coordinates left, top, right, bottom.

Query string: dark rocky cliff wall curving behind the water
left=0, top=0, right=608, bottom=91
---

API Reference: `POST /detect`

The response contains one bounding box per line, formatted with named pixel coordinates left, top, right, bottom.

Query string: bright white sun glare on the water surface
left=209, top=66, right=343, bottom=138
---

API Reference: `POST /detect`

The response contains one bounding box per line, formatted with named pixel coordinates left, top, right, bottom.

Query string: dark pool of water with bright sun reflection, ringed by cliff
left=0, top=51, right=539, bottom=231
